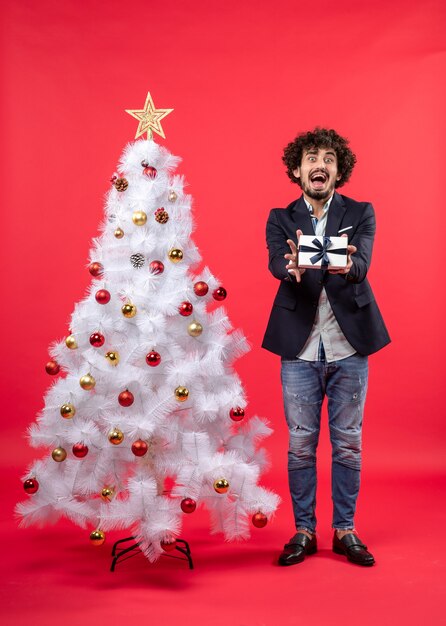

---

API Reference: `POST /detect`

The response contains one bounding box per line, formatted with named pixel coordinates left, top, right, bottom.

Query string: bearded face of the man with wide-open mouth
left=293, top=148, right=341, bottom=200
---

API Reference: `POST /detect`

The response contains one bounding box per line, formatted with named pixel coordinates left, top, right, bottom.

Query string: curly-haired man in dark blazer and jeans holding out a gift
left=262, top=128, right=390, bottom=566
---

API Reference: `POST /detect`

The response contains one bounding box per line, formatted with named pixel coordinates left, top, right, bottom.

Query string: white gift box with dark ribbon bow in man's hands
left=299, top=235, right=348, bottom=270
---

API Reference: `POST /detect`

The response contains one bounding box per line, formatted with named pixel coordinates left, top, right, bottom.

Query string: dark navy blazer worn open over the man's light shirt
left=262, top=193, right=390, bottom=358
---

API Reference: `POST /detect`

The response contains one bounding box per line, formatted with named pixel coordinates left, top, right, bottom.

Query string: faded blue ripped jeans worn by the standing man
left=281, top=354, right=368, bottom=533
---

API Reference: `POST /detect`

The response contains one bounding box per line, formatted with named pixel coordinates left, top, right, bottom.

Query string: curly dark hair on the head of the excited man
left=282, top=126, right=356, bottom=187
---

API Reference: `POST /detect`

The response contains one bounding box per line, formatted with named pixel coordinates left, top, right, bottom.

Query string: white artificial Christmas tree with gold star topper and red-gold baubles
left=17, top=94, right=279, bottom=561
